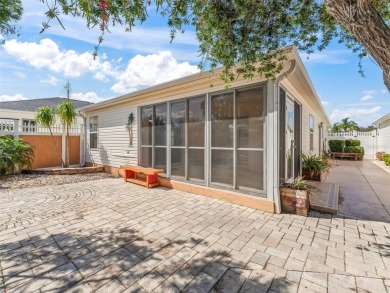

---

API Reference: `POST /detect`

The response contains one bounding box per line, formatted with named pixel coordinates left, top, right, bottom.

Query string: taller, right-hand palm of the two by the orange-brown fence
left=57, top=81, right=76, bottom=168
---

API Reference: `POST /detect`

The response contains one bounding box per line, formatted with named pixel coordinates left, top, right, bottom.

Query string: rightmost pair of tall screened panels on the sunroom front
left=210, top=88, right=264, bottom=191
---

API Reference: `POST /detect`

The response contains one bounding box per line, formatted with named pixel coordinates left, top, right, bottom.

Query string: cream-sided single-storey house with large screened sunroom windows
left=80, top=47, right=331, bottom=212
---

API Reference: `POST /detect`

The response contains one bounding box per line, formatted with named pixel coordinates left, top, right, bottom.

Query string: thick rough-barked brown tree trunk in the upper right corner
left=325, top=0, right=390, bottom=91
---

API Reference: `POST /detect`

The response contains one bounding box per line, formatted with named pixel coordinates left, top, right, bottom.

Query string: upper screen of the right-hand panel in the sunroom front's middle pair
left=188, top=98, right=205, bottom=147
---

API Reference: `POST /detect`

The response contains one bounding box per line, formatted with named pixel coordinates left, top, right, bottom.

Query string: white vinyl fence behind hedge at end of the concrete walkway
left=326, top=130, right=378, bottom=159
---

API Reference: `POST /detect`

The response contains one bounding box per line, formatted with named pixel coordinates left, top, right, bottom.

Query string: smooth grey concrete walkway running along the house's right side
left=327, top=160, right=390, bottom=223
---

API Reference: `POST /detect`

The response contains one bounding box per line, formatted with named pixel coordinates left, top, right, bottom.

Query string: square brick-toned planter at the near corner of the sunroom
left=280, top=187, right=310, bottom=217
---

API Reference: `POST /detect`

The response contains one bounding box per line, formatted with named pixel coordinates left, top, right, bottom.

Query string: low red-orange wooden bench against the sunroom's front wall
left=120, top=165, right=164, bottom=188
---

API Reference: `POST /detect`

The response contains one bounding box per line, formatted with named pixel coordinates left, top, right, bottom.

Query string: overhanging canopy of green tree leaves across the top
left=0, top=0, right=390, bottom=88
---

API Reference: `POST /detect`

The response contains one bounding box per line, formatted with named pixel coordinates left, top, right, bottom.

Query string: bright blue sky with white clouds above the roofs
left=0, top=0, right=390, bottom=125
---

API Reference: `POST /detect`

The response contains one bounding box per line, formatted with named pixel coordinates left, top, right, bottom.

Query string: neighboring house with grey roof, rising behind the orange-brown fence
left=0, top=97, right=92, bottom=132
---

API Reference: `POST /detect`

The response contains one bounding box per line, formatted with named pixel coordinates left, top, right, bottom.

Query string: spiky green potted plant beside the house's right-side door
left=302, top=154, right=330, bottom=181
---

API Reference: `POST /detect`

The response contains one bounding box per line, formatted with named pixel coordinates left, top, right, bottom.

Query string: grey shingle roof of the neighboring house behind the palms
left=0, top=97, right=93, bottom=112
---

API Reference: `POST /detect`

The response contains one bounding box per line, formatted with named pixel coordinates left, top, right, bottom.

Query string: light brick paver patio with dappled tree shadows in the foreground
left=0, top=179, right=390, bottom=293
